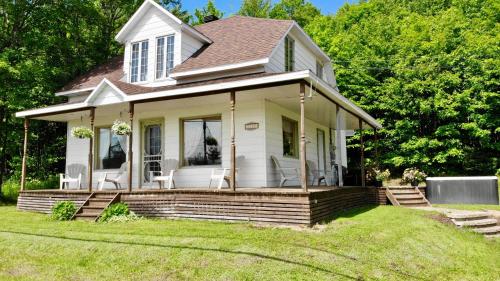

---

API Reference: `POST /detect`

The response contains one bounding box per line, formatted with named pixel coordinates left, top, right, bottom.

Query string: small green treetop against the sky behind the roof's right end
left=269, top=0, right=321, bottom=27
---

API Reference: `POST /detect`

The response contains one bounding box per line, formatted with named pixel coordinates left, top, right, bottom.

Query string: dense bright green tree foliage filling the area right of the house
left=307, top=0, right=500, bottom=175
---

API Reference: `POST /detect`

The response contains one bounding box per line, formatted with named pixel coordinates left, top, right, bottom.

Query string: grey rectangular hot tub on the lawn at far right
left=426, top=176, right=499, bottom=205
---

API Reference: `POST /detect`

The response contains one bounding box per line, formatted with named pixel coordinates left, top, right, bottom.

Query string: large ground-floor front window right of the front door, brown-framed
left=182, top=116, right=222, bottom=166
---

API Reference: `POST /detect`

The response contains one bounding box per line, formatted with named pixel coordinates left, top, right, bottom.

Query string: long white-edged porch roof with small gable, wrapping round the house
left=16, top=70, right=382, bottom=128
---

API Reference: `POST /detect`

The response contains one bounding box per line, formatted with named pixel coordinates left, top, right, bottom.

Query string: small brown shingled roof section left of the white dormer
left=60, top=55, right=125, bottom=92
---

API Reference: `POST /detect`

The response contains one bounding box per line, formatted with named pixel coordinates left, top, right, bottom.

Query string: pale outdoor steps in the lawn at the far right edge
left=447, top=212, right=500, bottom=238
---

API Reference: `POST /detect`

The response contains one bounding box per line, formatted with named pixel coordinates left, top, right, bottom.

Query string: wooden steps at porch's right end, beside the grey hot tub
left=385, top=186, right=431, bottom=207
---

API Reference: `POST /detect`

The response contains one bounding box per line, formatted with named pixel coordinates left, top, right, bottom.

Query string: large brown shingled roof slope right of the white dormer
left=174, top=16, right=293, bottom=73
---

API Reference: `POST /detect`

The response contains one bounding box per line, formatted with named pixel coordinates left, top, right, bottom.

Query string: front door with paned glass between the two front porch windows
left=142, top=121, right=163, bottom=184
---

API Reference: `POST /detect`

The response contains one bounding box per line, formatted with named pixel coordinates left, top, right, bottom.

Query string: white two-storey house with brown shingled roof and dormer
left=16, top=0, right=381, bottom=191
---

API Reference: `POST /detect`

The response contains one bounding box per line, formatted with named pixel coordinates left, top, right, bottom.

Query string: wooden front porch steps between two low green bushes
left=73, top=192, right=120, bottom=221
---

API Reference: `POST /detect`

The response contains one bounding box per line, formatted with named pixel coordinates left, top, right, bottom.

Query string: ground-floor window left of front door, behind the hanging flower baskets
left=96, top=127, right=127, bottom=170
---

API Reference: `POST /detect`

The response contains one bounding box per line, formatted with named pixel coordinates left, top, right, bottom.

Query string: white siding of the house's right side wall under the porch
left=265, top=101, right=330, bottom=186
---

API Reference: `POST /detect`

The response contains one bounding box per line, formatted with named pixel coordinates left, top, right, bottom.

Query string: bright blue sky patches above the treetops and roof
left=182, top=0, right=353, bottom=16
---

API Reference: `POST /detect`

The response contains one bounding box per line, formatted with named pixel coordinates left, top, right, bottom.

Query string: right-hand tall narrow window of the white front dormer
left=156, top=34, right=175, bottom=79
